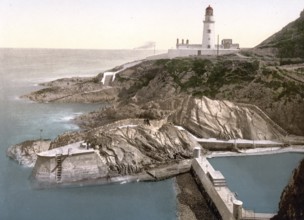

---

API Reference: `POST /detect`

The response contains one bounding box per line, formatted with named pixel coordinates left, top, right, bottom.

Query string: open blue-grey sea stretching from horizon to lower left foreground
left=0, top=48, right=177, bottom=220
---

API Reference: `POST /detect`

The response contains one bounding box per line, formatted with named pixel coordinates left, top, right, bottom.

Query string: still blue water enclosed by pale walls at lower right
left=208, top=153, right=304, bottom=213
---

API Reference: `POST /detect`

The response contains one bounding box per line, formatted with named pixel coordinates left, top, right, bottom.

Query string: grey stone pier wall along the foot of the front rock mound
left=31, top=156, right=192, bottom=188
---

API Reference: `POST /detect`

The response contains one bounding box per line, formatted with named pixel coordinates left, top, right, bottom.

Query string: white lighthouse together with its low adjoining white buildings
left=167, top=5, right=240, bottom=58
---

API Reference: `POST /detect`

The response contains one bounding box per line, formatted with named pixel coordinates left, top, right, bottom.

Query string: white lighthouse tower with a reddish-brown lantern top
left=202, top=5, right=215, bottom=49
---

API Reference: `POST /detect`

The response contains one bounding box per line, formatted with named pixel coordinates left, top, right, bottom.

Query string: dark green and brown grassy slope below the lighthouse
left=114, top=57, right=304, bottom=135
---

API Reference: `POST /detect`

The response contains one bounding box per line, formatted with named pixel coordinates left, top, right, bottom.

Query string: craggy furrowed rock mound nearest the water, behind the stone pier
left=85, top=120, right=199, bottom=175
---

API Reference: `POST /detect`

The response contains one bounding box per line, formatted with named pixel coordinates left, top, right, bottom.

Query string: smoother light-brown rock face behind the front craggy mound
left=170, top=97, right=284, bottom=140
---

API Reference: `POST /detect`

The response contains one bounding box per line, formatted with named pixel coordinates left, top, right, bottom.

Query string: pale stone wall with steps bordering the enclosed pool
left=192, top=146, right=304, bottom=220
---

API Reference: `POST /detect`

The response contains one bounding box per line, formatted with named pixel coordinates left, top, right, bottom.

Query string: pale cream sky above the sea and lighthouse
left=0, top=0, right=304, bottom=49
